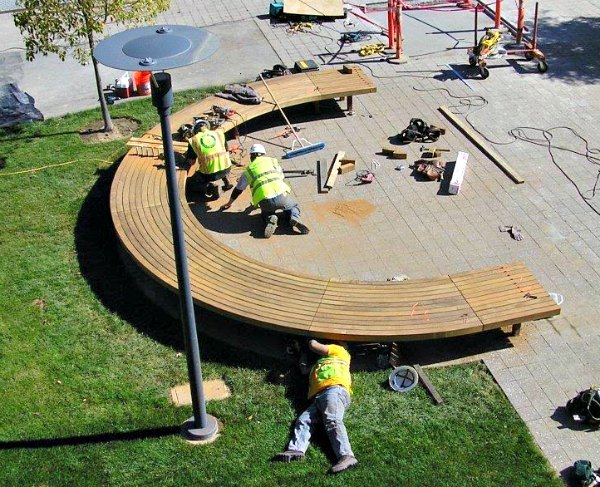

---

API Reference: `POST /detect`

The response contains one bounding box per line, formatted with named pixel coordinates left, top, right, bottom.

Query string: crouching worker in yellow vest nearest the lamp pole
left=185, top=122, right=233, bottom=199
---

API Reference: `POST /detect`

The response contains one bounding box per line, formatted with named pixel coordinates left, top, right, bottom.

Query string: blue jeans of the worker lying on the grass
left=288, top=386, right=354, bottom=459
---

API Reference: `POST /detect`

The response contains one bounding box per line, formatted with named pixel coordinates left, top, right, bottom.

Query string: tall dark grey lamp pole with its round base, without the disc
left=151, top=72, right=218, bottom=440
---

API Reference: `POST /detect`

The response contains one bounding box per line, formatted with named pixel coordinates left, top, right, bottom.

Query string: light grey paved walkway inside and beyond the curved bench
left=0, top=0, right=600, bottom=482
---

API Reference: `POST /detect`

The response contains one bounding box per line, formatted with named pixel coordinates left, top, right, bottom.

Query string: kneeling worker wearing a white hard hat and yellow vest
left=221, top=144, right=309, bottom=238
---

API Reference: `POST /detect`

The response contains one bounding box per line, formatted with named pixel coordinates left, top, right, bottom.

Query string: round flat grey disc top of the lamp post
left=94, top=25, right=219, bottom=71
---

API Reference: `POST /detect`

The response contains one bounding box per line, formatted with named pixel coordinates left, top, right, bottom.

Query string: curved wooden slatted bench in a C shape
left=110, top=68, right=560, bottom=342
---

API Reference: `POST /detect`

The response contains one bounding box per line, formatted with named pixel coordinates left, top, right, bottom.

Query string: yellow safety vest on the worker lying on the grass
left=308, top=345, right=352, bottom=399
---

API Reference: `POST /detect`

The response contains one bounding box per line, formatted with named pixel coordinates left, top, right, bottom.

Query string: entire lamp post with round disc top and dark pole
left=94, top=25, right=218, bottom=441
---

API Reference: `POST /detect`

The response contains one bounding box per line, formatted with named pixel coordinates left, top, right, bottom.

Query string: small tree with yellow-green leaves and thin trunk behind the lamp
left=14, top=0, right=170, bottom=132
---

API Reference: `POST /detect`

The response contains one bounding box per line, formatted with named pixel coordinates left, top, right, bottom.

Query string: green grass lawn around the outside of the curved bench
left=0, top=92, right=562, bottom=487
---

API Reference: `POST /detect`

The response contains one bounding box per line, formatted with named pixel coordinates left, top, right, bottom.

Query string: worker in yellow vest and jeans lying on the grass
left=274, top=340, right=358, bottom=473
